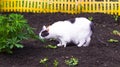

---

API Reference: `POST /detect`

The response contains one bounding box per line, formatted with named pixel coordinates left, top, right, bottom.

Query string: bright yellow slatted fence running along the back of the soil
left=0, top=0, right=120, bottom=15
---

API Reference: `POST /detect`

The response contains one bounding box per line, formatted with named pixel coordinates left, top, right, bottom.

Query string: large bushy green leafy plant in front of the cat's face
left=0, top=14, right=35, bottom=53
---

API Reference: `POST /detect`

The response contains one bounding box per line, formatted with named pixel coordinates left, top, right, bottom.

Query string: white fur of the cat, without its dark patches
left=39, top=17, right=92, bottom=47
